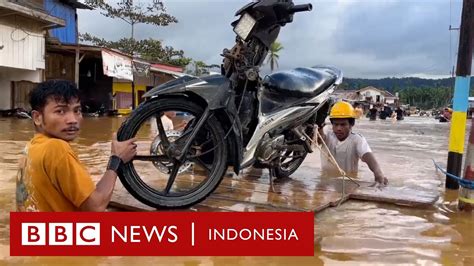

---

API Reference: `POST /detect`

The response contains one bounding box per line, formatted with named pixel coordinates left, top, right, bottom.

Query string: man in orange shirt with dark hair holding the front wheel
left=16, top=80, right=136, bottom=211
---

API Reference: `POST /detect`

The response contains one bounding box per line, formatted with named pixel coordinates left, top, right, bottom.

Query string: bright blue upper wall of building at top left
left=44, top=0, right=76, bottom=43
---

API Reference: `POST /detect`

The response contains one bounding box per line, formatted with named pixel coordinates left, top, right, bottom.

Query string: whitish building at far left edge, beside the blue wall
left=0, top=0, right=66, bottom=110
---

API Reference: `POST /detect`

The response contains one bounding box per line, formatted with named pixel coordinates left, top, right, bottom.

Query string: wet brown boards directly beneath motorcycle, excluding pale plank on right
left=111, top=172, right=348, bottom=212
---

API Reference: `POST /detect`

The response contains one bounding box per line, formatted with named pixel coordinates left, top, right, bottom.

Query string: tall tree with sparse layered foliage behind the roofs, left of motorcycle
left=80, top=0, right=191, bottom=66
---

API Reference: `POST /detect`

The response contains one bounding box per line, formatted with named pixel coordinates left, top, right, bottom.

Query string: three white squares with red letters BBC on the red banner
left=21, top=223, right=100, bottom=246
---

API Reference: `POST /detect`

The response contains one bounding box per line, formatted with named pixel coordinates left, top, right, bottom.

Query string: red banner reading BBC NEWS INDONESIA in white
left=10, top=212, right=314, bottom=256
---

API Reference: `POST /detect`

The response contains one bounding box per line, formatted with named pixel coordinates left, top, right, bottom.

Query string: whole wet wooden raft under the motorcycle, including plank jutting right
left=110, top=171, right=439, bottom=212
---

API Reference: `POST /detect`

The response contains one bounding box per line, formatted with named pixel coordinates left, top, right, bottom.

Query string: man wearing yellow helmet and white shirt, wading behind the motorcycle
left=319, top=102, right=388, bottom=185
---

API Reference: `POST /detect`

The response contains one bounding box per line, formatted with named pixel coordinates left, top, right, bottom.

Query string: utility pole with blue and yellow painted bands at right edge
left=446, top=0, right=474, bottom=189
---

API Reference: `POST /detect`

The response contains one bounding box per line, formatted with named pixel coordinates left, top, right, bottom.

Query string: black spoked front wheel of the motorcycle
left=117, top=98, right=228, bottom=208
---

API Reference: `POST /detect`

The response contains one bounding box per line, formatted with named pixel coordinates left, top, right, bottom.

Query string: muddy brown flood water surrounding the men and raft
left=0, top=117, right=474, bottom=265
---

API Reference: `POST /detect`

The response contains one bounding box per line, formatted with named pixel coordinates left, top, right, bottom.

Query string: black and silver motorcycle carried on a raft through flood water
left=118, top=0, right=342, bottom=208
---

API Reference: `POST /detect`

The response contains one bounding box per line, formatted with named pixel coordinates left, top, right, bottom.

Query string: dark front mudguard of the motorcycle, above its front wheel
left=143, top=75, right=243, bottom=174
